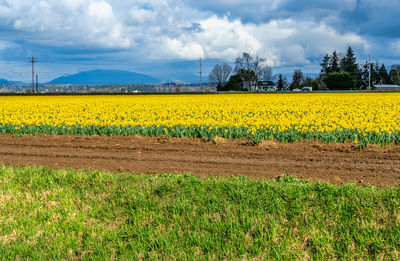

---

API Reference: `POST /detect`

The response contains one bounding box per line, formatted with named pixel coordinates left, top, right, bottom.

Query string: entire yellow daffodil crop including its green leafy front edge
left=0, top=93, right=400, bottom=146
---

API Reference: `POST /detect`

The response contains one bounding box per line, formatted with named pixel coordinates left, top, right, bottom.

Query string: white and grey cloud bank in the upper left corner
left=0, top=0, right=132, bottom=48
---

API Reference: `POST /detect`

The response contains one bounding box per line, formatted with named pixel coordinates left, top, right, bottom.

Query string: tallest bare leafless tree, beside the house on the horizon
left=235, top=53, right=266, bottom=88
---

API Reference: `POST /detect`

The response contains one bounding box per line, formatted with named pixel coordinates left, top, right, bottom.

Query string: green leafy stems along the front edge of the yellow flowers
left=0, top=124, right=400, bottom=147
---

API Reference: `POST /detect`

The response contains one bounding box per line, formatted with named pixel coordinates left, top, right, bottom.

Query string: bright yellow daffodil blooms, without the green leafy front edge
left=0, top=93, right=400, bottom=144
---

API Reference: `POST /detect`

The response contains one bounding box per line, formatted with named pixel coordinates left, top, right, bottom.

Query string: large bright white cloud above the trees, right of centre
left=146, top=15, right=367, bottom=66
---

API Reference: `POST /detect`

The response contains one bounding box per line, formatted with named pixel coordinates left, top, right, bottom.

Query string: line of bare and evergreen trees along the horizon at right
left=209, top=47, right=400, bottom=91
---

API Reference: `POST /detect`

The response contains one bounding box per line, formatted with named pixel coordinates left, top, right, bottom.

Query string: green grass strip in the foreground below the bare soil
left=0, top=167, right=400, bottom=260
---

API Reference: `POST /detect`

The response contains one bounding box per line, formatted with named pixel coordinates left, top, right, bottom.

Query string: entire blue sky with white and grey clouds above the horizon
left=0, top=0, right=400, bottom=82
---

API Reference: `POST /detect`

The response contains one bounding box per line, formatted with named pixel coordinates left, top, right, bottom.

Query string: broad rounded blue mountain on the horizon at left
left=48, top=70, right=160, bottom=85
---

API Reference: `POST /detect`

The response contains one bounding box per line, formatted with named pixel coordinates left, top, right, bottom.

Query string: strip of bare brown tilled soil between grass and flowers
left=0, top=135, right=400, bottom=187
